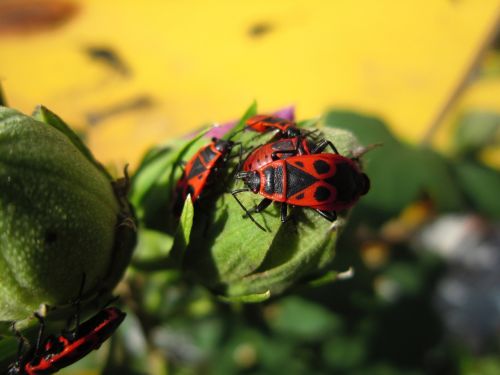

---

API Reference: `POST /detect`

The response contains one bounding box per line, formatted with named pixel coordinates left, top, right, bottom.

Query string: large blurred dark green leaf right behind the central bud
left=325, top=111, right=463, bottom=219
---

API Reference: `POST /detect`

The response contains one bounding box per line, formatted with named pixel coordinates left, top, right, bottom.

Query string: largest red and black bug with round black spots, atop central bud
left=231, top=140, right=370, bottom=230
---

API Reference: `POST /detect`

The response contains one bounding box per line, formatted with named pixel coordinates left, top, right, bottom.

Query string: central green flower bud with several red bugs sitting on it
left=132, top=111, right=368, bottom=302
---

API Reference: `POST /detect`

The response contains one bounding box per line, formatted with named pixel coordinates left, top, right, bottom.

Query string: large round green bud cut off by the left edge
left=0, top=107, right=134, bottom=321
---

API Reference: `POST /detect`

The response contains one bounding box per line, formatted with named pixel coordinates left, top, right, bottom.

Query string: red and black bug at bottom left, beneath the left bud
left=7, top=307, right=126, bottom=375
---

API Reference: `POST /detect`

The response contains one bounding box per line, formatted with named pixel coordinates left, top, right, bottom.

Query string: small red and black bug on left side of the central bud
left=173, top=138, right=241, bottom=216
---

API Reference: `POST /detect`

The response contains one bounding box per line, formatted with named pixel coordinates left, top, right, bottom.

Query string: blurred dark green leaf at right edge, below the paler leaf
left=454, top=160, right=500, bottom=219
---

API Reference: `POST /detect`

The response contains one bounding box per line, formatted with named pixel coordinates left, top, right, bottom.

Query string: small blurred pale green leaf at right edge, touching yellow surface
left=453, top=111, right=500, bottom=155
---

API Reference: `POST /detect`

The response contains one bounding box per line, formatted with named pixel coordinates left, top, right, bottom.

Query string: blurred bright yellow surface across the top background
left=0, top=0, right=500, bottom=166
